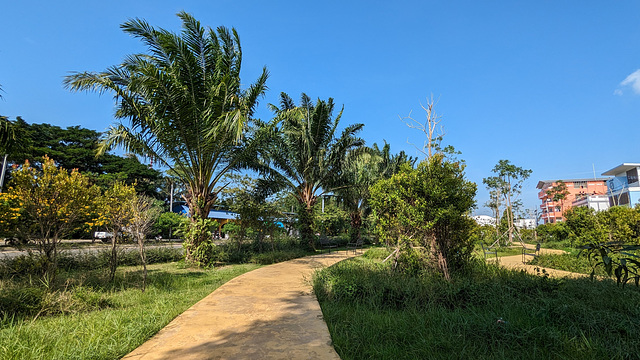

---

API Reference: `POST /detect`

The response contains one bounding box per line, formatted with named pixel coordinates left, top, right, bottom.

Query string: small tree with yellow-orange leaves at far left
left=7, top=157, right=100, bottom=279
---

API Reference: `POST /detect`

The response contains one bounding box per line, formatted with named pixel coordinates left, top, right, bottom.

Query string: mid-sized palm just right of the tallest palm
left=263, top=93, right=364, bottom=248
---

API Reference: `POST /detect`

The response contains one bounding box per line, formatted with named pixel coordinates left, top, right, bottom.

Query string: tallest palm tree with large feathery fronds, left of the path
left=64, top=12, right=268, bottom=258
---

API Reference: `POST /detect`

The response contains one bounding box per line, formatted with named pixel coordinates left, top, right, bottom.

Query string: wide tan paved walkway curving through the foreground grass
left=124, top=251, right=353, bottom=360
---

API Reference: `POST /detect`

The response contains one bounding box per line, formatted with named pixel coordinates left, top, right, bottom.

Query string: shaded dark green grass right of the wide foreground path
left=314, top=250, right=640, bottom=360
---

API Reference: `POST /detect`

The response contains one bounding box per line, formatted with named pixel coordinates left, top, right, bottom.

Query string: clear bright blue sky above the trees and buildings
left=0, top=0, right=640, bottom=214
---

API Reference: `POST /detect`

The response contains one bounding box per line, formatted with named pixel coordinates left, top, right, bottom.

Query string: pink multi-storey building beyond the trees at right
left=536, top=178, right=609, bottom=224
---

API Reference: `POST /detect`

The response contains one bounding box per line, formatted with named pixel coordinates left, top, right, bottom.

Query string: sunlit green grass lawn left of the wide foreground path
left=0, top=263, right=259, bottom=360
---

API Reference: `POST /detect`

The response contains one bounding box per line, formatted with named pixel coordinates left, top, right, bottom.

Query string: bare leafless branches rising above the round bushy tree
left=400, top=94, right=445, bottom=158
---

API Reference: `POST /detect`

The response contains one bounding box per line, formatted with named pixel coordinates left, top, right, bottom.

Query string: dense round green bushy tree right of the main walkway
left=371, top=154, right=476, bottom=279
